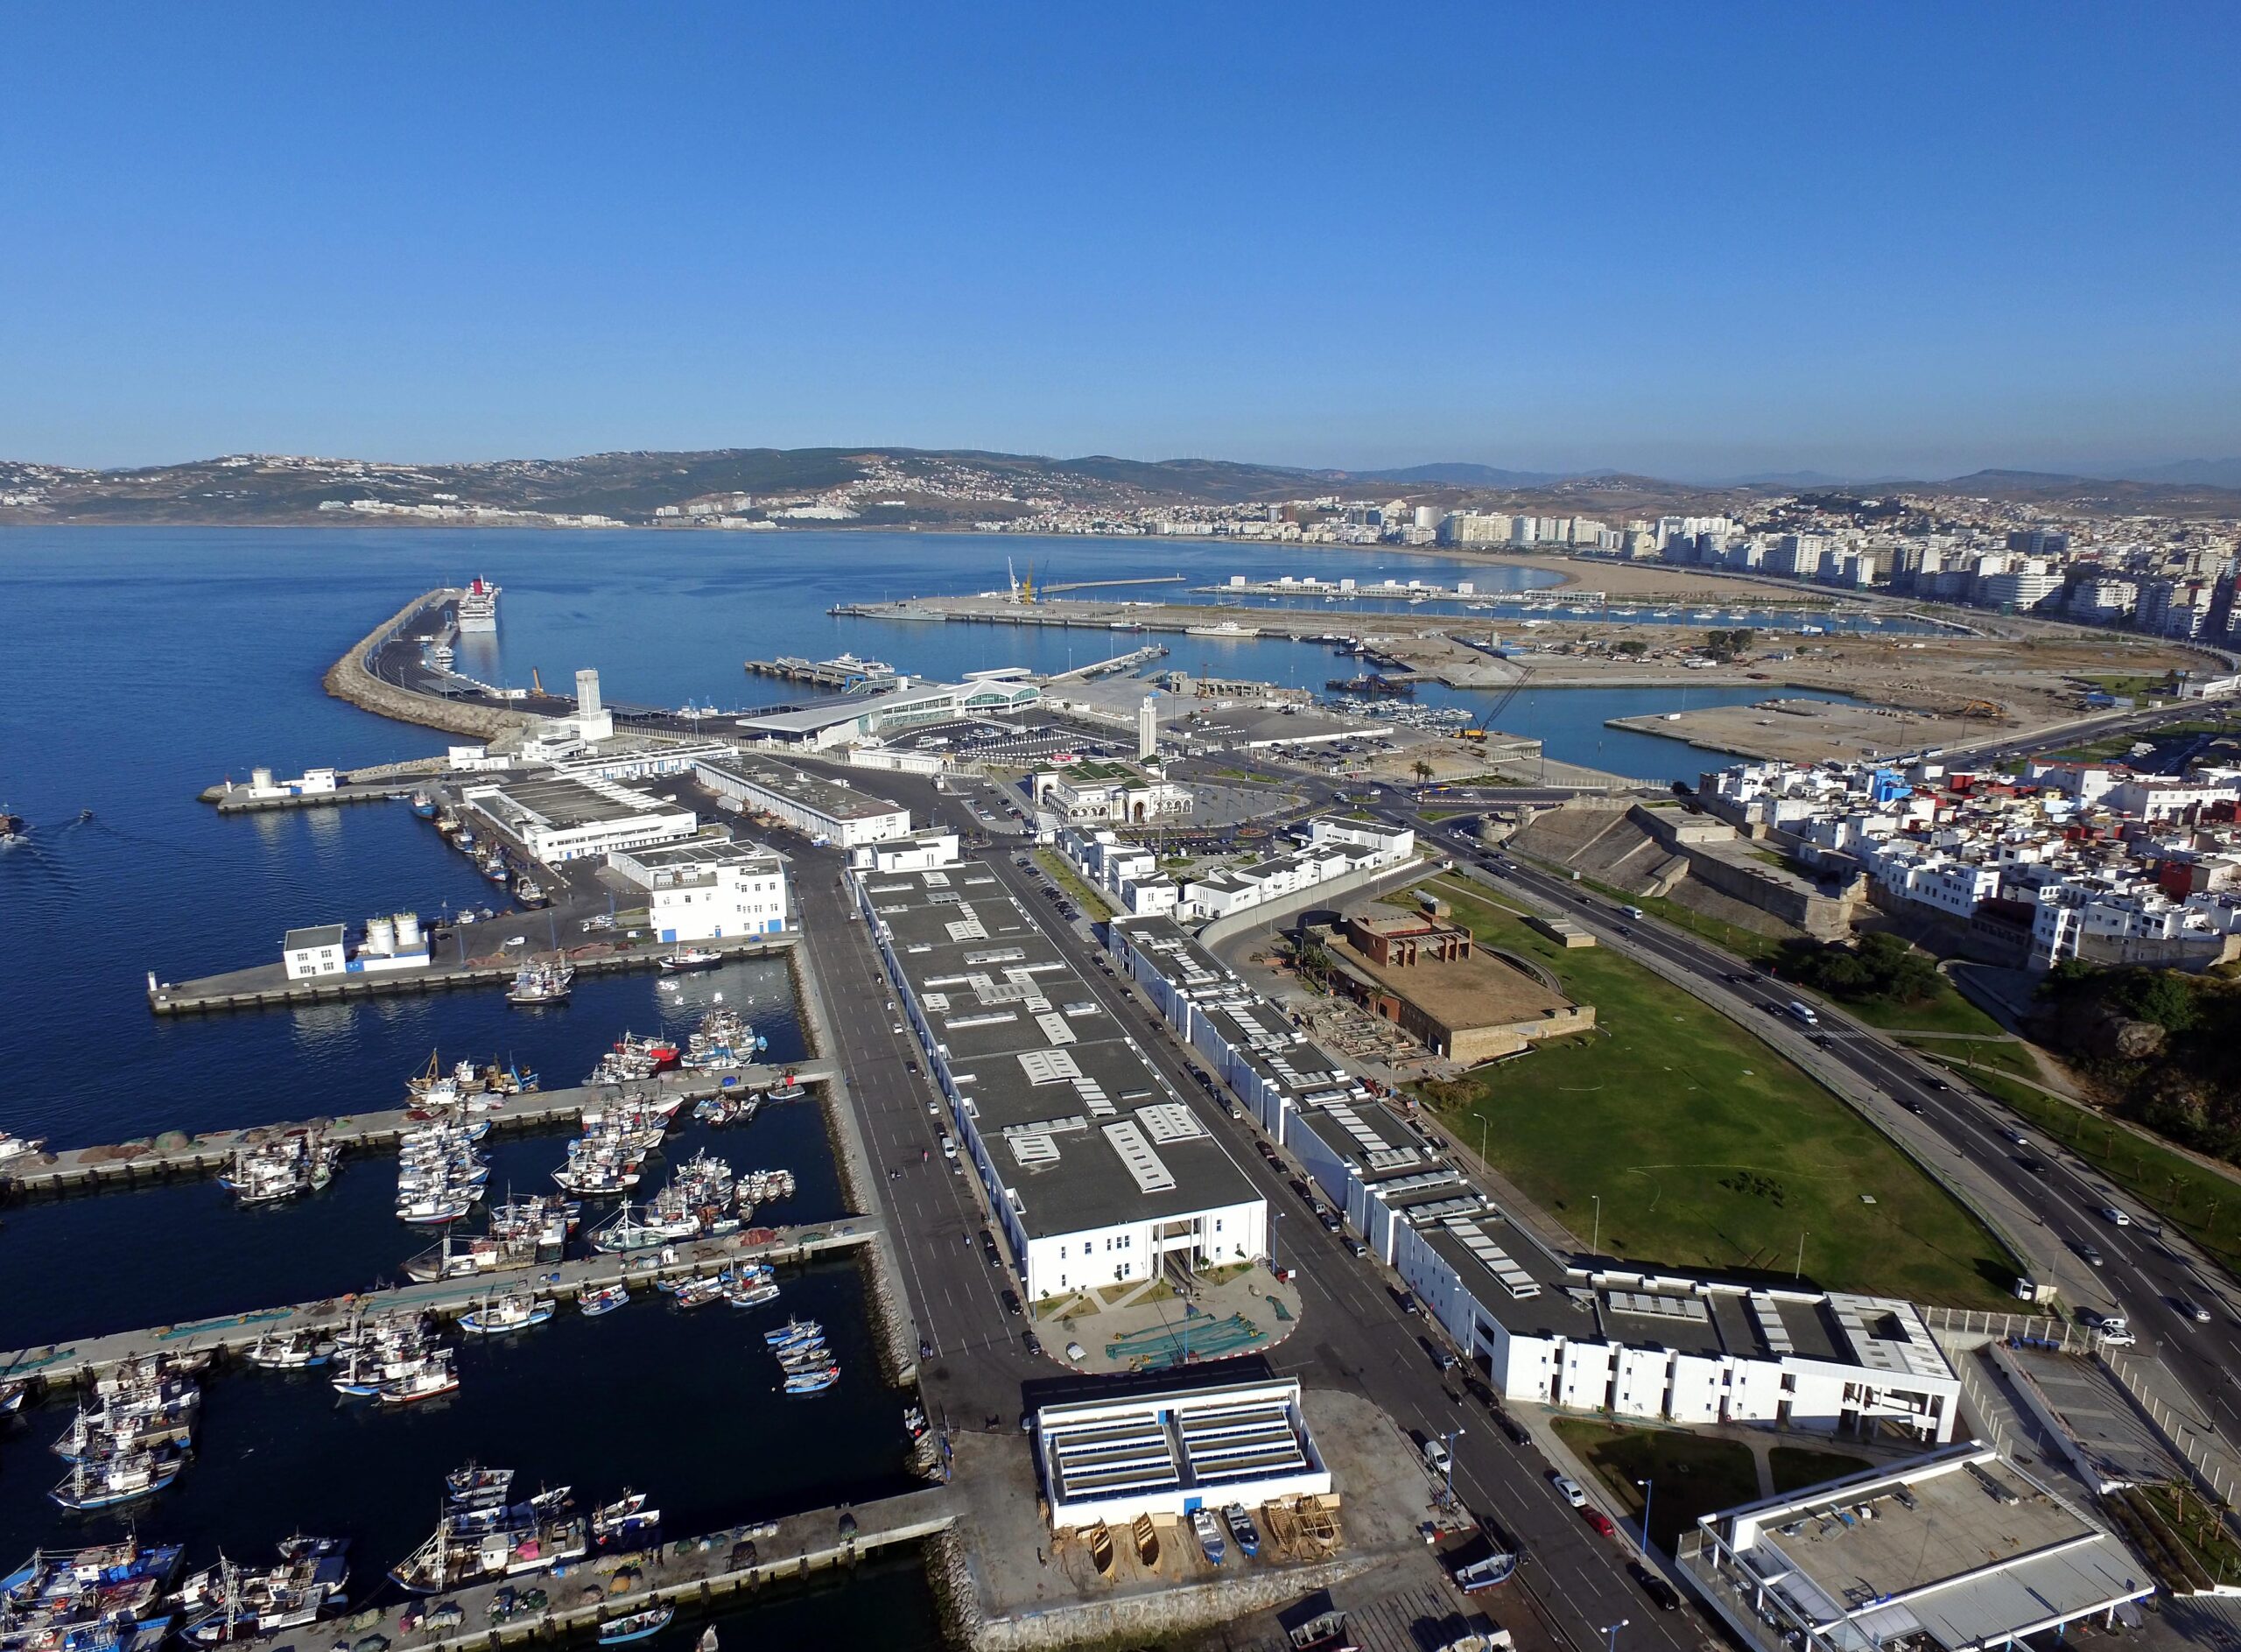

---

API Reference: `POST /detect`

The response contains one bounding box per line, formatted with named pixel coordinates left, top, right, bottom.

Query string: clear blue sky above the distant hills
left=0, top=0, right=2241, bottom=475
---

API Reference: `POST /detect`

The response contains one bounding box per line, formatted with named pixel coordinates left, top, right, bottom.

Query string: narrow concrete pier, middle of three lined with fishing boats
left=0, top=1217, right=881, bottom=1383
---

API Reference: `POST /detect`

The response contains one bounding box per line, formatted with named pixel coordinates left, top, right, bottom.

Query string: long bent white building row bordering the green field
left=1107, top=919, right=1961, bottom=1441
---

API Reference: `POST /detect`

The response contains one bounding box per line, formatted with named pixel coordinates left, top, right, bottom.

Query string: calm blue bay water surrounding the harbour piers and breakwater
left=0, top=529, right=1810, bottom=1648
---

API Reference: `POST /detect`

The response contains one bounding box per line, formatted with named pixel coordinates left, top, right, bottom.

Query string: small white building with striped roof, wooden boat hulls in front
left=1036, top=1379, right=1331, bottom=1531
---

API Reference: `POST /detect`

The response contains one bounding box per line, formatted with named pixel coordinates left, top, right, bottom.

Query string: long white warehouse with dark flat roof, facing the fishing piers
left=849, top=838, right=1268, bottom=1300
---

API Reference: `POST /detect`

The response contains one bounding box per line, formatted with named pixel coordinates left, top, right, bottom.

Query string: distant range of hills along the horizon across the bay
left=0, top=448, right=2241, bottom=527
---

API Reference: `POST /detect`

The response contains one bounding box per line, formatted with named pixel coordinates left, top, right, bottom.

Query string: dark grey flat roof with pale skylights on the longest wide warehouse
left=861, top=861, right=1261, bottom=1237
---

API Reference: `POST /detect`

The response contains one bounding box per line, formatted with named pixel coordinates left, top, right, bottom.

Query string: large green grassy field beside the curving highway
left=1434, top=879, right=2020, bottom=1307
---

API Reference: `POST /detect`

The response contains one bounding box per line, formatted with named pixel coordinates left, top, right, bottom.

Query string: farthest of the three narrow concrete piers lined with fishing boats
left=0, top=1060, right=836, bottom=1195
